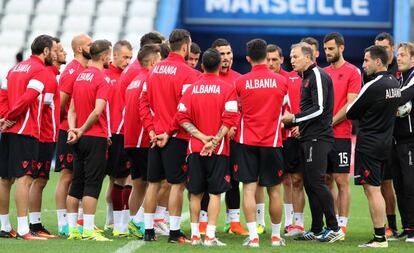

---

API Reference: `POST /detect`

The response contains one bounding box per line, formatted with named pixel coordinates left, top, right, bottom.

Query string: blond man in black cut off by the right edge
left=392, top=43, right=414, bottom=242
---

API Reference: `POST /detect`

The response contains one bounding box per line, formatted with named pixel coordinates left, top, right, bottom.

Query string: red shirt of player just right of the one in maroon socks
left=124, top=68, right=150, bottom=148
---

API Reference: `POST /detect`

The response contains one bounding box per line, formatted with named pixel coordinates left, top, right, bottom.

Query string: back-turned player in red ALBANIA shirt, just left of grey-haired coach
left=234, top=39, right=287, bottom=247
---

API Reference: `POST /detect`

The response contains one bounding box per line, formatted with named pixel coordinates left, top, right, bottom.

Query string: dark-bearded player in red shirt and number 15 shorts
left=323, top=32, right=362, bottom=237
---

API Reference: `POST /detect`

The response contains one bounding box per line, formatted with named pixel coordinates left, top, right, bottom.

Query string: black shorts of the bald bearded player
left=55, top=129, right=73, bottom=172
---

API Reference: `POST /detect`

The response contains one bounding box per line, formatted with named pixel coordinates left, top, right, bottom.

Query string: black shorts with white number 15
left=326, top=138, right=352, bottom=173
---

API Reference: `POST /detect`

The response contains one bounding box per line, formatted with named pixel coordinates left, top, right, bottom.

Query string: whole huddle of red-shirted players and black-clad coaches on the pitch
left=0, top=29, right=414, bottom=248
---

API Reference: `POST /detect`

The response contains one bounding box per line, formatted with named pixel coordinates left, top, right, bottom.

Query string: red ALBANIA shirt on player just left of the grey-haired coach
left=235, top=64, right=288, bottom=147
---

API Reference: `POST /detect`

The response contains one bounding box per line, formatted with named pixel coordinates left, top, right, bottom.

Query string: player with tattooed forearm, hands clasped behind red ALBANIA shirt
left=177, top=49, right=239, bottom=246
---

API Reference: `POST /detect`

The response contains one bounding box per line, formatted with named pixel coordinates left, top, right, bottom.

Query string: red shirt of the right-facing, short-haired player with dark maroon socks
left=104, top=63, right=125, bottom=134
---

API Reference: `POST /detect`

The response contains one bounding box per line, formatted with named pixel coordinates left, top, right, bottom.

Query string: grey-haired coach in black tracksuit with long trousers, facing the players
left=282, top=43, right=343, bottom=242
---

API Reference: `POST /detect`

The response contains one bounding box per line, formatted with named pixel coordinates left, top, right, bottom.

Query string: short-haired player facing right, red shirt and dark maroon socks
left=104, top=40, right=132, bottom=237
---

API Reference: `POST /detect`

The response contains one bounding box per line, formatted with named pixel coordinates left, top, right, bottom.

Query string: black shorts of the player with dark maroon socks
left=105, top=134, right=130, bottom=178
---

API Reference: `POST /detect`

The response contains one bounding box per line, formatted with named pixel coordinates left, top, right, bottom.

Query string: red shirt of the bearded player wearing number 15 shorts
left=324, top=62, right=362, bottom=138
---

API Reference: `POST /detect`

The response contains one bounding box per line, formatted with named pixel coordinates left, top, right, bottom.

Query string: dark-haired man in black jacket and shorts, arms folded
left=346, top=46, right=401, bottom=247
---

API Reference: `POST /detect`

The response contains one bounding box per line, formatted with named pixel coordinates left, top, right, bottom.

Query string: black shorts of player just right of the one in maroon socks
left=125, top=148, right=148, bottom=181
